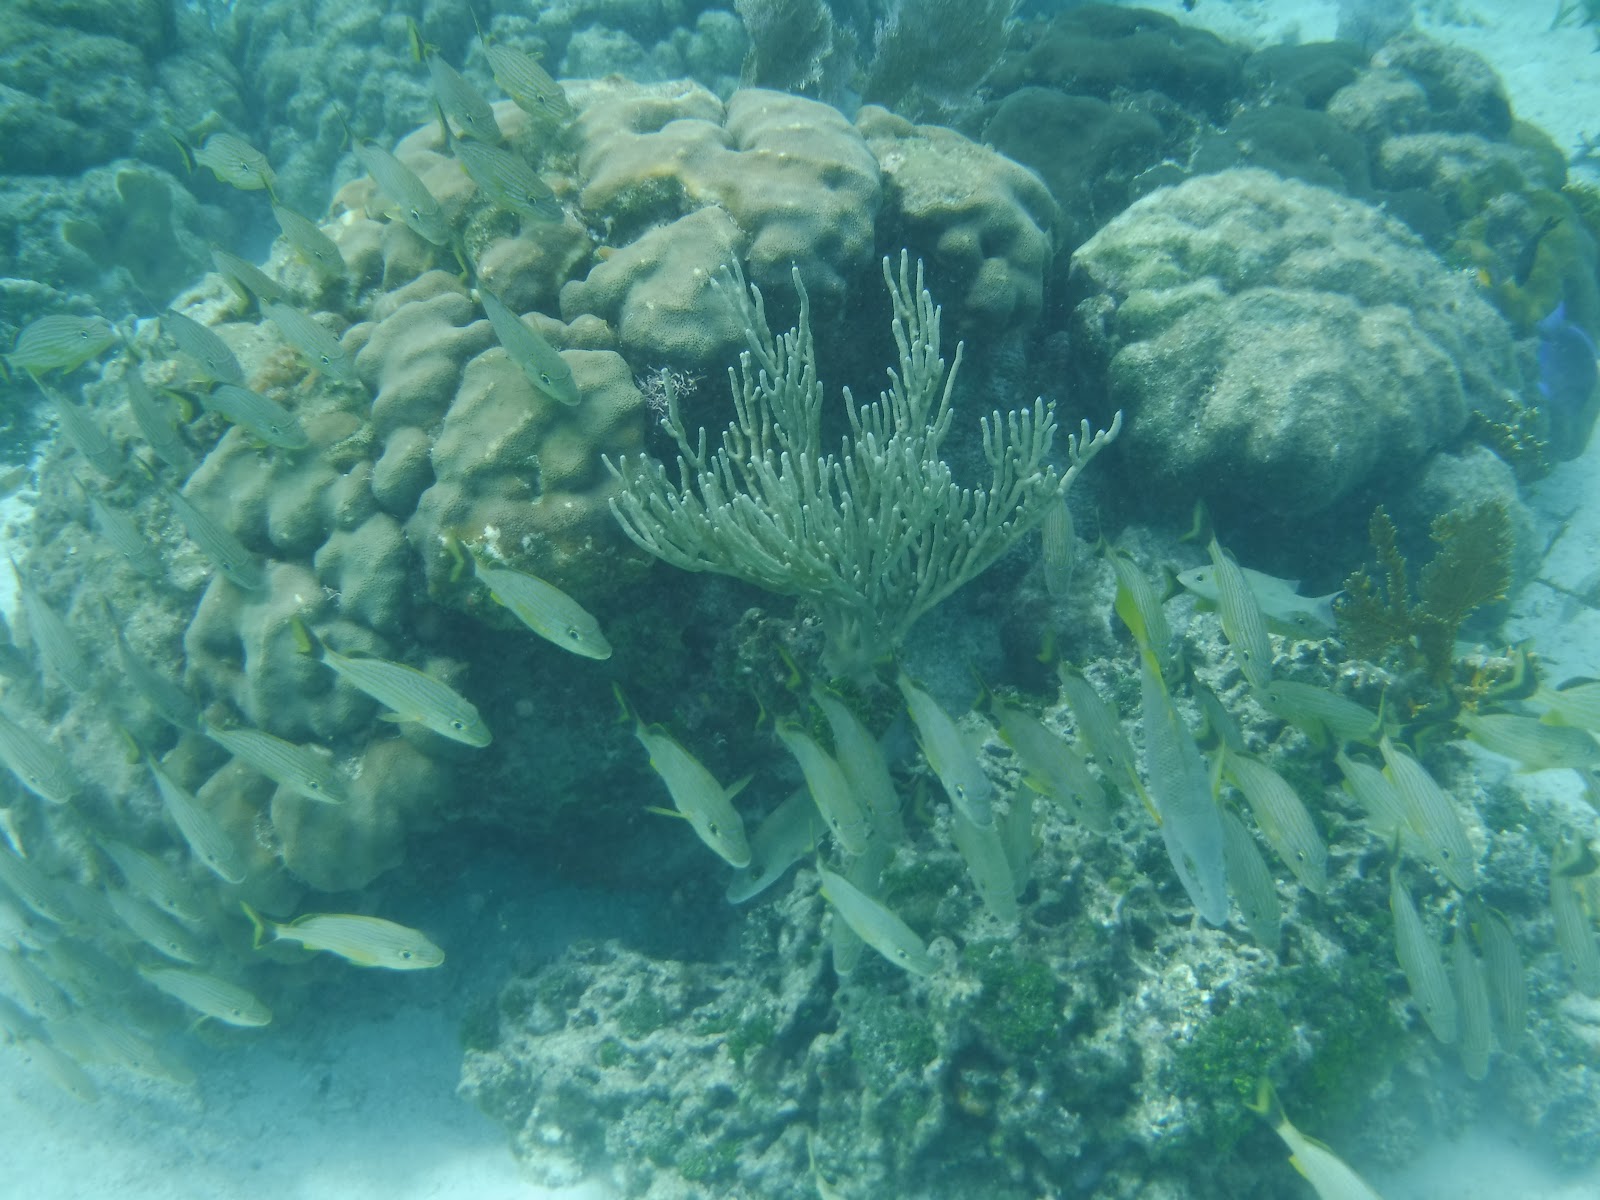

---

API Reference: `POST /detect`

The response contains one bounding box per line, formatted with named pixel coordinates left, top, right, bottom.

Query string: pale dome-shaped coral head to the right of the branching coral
left=1074, top=170, right=1522, bottom=515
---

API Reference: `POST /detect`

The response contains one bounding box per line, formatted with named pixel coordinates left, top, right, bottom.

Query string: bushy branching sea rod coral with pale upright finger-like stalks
left=606, top=253, right=1122, bottom=674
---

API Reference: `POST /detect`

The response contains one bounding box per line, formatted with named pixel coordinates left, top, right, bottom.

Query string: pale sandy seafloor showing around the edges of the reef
left=9, top=0, right=1600, bottom=1200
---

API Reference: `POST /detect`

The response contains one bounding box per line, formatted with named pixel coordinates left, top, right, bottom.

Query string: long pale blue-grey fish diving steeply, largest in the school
left=1139, top=654, right=1227, bottom=925
